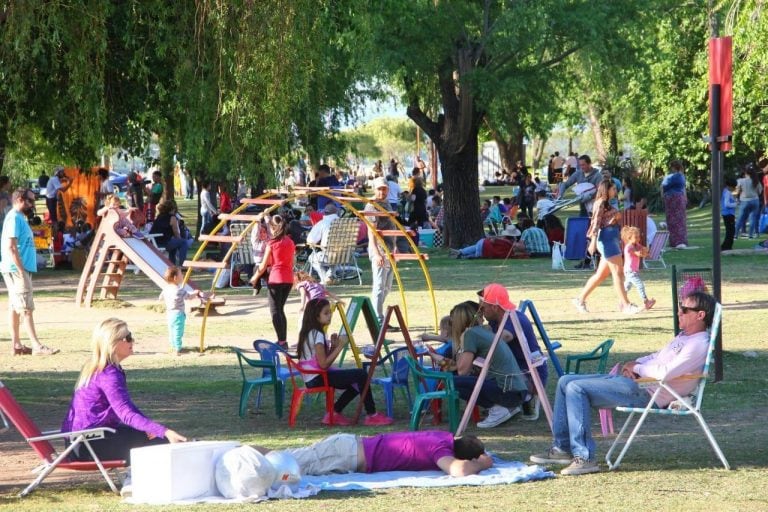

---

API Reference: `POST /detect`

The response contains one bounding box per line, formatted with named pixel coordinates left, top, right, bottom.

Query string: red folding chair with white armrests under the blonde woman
left=0, top=381, right=126, bottom=498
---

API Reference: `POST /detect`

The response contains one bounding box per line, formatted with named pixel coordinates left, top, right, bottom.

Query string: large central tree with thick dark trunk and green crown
left=361, top=0, right=639, bottom=247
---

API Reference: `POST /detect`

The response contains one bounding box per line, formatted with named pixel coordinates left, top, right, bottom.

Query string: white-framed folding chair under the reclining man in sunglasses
left=605, top=304, right=731, bottom=469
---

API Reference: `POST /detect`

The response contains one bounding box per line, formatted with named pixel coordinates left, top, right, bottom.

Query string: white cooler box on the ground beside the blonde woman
left=131, top=441, right=240, bottom=504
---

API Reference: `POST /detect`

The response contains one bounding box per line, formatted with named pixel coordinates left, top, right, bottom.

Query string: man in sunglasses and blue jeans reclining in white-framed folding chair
left=531, top=291, right=716, bottom=475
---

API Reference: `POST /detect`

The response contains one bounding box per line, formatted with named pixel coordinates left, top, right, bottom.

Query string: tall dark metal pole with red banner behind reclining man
left=709, top=84, right=723, bottom=382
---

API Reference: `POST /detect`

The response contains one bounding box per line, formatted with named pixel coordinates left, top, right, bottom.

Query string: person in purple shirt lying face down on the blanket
left=254, top=430, right=493, bottom=476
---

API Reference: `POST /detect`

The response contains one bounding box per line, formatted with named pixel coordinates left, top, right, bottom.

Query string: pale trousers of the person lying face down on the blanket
left=282, top=434, right=358, bottom=475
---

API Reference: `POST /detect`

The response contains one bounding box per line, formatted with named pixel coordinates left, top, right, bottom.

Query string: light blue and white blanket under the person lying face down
left=129, top=456, right=555, bottom=505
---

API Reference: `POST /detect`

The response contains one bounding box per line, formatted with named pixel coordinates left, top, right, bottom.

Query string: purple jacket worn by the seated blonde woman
left=61, top=364, right=167, bottom=437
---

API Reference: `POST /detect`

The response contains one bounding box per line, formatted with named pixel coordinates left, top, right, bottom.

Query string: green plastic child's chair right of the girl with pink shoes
left=405, top=354, right=459, bottom=432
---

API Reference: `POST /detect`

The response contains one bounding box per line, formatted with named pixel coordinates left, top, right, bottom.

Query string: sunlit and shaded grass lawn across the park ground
left=0, top=195, right=768, bottom=512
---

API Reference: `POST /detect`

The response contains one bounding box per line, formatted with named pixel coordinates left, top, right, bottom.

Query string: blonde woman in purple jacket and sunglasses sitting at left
left=61, top=318, right=187, bottom=464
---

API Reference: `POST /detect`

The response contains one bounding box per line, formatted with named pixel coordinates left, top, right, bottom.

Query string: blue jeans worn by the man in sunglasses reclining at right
left=552, top=375, right=651, bottom=460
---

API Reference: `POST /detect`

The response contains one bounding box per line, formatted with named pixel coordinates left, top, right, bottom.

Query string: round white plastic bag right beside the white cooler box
left=215, top=446, right=277, bottom=499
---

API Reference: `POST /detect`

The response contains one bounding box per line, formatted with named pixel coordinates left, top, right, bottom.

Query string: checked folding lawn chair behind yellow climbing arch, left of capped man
left=313, top=217, right=363, bottom=285
